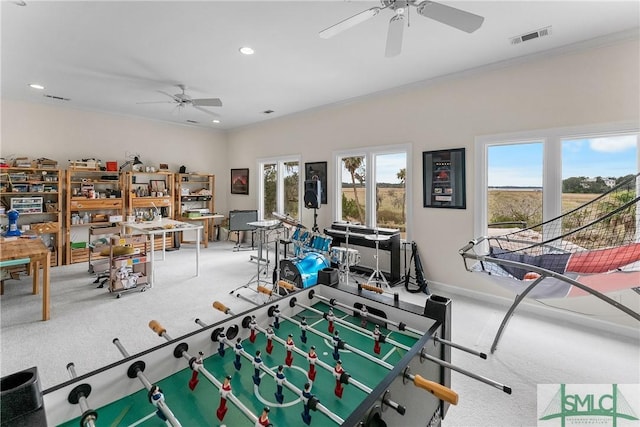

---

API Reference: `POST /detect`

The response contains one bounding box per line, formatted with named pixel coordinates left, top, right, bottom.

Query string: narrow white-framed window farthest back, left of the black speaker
left=258, top=157, right=300, bottom=219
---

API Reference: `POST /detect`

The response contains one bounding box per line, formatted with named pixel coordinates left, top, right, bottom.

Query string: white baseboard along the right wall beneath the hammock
left=429, top=280, right=640, bottom=343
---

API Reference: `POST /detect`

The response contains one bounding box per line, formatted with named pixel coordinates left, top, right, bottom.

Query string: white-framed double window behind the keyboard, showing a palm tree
left=335, top=145, right=411, bottom=237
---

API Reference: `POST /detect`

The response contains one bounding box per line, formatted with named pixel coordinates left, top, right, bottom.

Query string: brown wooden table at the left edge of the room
left=0, top=238, right=51, bottom=320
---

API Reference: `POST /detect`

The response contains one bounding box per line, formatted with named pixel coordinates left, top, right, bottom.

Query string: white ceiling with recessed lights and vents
left=0, top=0, right=640, bottom=129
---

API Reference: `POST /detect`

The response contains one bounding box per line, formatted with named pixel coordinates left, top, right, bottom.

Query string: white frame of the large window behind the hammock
left=473, top=122, right=640, bottom=236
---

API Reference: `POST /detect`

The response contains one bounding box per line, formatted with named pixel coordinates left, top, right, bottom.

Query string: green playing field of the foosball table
left=62, top=303, right=418, bottom=427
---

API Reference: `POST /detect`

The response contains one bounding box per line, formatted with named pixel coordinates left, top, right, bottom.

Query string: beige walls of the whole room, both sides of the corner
left=2, top=40, right=640, bottom=325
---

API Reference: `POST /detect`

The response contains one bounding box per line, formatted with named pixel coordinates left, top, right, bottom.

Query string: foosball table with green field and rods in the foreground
left=2, top=285, right=511, bottom=427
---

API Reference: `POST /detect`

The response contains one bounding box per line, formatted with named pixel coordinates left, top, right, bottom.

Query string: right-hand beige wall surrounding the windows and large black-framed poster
left=229, top=40, right=640, bottom=326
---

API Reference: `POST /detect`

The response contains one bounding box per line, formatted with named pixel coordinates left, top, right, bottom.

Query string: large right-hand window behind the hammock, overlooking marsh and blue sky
left=475, top=124, right=640, bottom=236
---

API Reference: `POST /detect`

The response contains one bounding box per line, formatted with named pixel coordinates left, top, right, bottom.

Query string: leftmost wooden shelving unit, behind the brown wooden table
left=0, top=167, right=64, bottom=266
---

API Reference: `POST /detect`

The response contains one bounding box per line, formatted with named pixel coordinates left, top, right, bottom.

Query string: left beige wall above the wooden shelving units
left=0, top=99, right=229, bottom=212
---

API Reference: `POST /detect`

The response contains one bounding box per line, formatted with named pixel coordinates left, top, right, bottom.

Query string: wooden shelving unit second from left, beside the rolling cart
left=65, top=168, right=124, bottom=264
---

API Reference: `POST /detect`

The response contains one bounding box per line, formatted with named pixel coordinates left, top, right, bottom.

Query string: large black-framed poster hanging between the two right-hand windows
left=422, top=148, right=467, bottom=209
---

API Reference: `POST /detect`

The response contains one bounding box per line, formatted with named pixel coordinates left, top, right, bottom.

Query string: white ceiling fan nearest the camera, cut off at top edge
left=320, top=0, right=484, bottom=57
